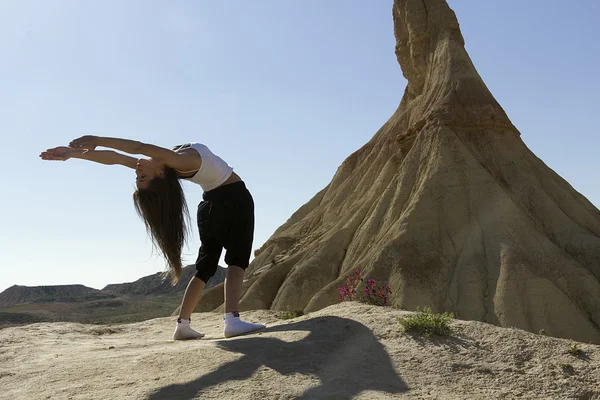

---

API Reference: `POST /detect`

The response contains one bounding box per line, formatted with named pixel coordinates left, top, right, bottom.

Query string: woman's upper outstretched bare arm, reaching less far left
left=69, top=135, right=202, bottom=171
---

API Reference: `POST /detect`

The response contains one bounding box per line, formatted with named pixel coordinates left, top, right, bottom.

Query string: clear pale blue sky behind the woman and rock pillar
left=0, top=0, right=600, bottom=291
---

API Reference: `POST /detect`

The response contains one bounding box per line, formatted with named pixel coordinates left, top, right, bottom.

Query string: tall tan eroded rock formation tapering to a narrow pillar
left=232, top=0, right=600, bottom=343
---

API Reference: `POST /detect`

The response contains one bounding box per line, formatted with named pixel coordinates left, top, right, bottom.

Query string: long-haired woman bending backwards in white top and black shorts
left=40, top=135, right=265, bottom=340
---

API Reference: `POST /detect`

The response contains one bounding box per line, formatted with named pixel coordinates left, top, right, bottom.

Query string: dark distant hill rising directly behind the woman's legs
left=102, top=265, right=227, bottom=296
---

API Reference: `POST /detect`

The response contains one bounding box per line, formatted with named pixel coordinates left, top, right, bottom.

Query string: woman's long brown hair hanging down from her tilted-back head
left=133, top=166, right=190, bottom=285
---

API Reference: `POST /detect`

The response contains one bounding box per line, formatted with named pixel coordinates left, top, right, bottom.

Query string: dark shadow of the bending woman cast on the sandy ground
left=149, top=317, right=408, bottom=399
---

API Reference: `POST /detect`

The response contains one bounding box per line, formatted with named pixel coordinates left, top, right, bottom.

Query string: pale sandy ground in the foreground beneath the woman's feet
left=0, top=303, right=600, bottom=400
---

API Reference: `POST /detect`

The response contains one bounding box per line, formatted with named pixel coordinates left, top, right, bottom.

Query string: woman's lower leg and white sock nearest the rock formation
left=223, top=265, right=265, bottom=338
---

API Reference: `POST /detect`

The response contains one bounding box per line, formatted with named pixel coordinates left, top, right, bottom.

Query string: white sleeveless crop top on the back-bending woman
left=175, top=143, right=233, bottom=192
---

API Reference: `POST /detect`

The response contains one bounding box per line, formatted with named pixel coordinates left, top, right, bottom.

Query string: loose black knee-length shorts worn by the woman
left=196, top=182, right=254, bottom=283
